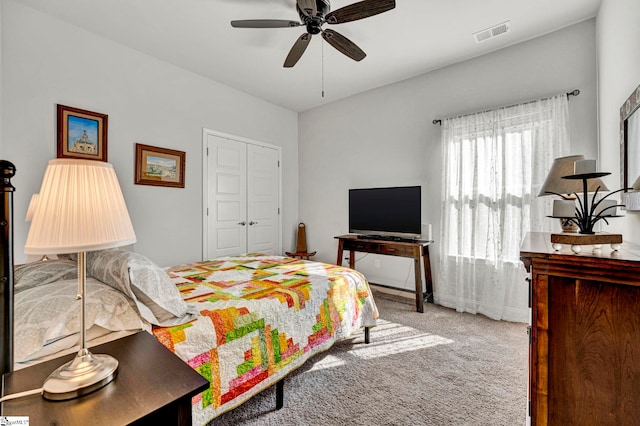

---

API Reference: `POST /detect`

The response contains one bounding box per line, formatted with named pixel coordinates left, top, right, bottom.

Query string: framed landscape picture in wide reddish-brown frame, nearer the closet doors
left=135, top=143, right=185, bottom=188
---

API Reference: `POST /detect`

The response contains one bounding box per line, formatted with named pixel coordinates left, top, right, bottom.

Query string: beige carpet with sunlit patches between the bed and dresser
left=211, top=292, right=528, bottom=426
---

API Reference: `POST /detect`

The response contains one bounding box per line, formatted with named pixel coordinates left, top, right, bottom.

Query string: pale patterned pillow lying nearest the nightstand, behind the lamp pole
left=14, top=278, right=145, bottom=363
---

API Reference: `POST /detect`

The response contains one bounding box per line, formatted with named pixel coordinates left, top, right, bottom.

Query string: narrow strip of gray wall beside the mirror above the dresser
left=597, top=0, right=640, bottom=244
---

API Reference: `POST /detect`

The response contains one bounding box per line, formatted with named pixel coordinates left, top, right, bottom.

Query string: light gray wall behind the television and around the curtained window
left=299, top=20, right=597, bottom=289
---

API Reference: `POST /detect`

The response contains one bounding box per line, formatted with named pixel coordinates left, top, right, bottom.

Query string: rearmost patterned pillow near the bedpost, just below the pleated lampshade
left=13, top=260, right=78, bottom=293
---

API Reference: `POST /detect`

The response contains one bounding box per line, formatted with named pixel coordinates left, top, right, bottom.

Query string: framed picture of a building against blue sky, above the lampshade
left=58, top=104, right=108, bottom=161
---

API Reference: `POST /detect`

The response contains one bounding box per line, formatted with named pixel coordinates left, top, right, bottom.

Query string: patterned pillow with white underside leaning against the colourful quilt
left=87, top=249, right=197, bottom=326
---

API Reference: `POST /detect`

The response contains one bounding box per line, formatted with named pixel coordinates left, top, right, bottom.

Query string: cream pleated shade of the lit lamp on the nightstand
left=24, top=158, right=136, bottom=254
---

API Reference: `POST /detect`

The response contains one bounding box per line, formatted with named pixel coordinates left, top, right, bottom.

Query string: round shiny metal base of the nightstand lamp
left=42, top=348, right=118, bottom=401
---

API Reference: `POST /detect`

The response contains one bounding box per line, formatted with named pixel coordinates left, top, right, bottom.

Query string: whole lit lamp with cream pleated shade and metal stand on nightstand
left=24, top=158, right=136, bottom=400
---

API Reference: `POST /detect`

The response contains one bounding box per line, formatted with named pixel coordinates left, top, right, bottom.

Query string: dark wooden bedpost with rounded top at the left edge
left=0, top=160, right=16, bottom=374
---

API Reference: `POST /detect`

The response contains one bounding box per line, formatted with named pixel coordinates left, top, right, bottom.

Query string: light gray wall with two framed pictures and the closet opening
left=1, top=0, right=298, bottom=265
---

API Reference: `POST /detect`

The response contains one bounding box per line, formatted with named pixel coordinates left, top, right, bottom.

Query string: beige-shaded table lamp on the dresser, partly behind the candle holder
left=538, top=155, right=609, bottom=232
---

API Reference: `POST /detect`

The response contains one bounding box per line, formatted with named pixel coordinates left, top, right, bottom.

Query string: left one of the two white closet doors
left=206, top=134, right=248, bottom=259
